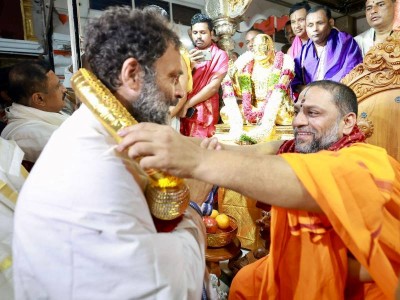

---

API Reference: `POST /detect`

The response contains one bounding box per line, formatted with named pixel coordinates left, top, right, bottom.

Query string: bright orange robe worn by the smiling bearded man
left=229, top=143, right=400, bottom=300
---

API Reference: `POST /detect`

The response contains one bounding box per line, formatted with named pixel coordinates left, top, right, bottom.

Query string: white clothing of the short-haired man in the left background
left=1, top=103, right=68, bottom=162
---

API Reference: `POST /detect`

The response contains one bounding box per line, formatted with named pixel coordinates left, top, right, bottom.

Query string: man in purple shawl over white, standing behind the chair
left=291, top=6, right=362, bottom=93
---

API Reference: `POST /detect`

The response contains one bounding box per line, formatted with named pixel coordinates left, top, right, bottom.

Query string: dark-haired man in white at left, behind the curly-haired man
left=1, top=62, right=68, bottom=164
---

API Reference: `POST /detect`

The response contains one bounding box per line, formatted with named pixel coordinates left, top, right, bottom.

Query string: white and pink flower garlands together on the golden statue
left=222, top=52, right=294, bottom=144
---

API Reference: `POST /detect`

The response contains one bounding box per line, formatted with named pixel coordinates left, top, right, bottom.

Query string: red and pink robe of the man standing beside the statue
left=181, top=43, right=229, bottom=137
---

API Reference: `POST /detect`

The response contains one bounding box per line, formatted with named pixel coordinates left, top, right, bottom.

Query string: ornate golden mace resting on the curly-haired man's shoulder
left=71, top=69, right=190, bottom=220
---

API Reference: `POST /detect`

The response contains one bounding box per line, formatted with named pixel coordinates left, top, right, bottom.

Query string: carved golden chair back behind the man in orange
left=342, top=31, right=400, bottom=160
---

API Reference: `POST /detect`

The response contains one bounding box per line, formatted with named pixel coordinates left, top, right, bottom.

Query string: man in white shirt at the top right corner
left=354, top=0, right=395, bottom=57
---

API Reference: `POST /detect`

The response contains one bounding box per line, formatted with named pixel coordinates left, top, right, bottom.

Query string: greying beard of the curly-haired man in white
left=130, top=74, right=177, bottom=124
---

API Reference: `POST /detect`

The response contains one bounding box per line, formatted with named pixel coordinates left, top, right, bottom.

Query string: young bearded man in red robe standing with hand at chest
left=181, top=14, right=229, bottom=137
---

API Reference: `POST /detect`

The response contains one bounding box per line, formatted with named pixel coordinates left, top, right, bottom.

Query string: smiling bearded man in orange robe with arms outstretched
left=118, top=81, right=400, bottom=299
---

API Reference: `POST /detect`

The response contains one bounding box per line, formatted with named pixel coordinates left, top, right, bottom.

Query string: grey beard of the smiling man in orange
left=294, top=120, right=339, bottom=153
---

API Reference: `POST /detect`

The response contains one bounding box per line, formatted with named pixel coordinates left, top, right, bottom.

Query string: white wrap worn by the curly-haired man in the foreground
left=13, top=105, right=205, bottom=300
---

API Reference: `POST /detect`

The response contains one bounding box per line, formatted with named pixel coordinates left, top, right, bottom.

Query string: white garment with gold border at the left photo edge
left=0, top=138, right=28, bottom=300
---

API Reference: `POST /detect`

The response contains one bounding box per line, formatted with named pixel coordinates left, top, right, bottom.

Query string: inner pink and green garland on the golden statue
left=239, top=52, right=284, bottom=123
